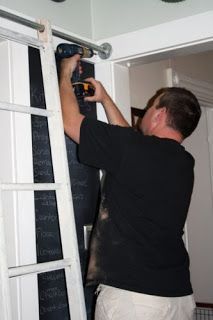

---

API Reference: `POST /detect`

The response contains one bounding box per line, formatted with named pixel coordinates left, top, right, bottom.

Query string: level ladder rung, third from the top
left=0, top=183, right=61, bottom=191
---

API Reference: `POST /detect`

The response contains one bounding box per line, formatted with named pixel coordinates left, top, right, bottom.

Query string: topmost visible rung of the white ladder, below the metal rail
left=0, top=27, right=44, bottom=48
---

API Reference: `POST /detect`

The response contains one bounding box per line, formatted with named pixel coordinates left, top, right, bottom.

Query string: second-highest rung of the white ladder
left=0, top=101, right=54, bottom=117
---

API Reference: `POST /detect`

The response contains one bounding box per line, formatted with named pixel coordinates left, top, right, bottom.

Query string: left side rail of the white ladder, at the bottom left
left=0, top=190, right=12, bottom=320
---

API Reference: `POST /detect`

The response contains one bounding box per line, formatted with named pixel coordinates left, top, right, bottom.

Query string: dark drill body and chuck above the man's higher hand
left=56, top=43, right=94, bottom=59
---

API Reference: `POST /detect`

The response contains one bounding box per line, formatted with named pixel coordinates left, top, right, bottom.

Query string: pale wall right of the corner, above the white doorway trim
left=91, top=0, right=213, bottom=40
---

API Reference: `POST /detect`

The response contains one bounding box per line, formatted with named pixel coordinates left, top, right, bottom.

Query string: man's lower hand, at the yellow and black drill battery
left=84, top=78, right=110, bottom=105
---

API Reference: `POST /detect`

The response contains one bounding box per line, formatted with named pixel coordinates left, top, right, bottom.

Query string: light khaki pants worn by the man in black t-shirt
left=95, top=284, right=195, bottom=320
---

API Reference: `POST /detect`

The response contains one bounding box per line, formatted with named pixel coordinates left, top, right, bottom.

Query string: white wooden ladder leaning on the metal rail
left=0, top=20, right=86, bottom=320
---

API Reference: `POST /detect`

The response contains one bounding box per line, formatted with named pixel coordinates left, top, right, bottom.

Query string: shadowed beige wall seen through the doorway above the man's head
left=129, top=51, right=213, bottom=109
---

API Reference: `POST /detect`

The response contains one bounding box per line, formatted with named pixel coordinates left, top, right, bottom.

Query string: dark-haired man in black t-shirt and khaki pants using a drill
left=59, top=55, right=201, bottom=320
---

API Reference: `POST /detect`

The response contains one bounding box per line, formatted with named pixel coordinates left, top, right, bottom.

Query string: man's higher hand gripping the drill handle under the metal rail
left=60, top=54, right=81, bottom=80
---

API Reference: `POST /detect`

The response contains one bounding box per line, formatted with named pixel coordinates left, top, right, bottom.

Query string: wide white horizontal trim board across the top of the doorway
left=96, top=11, right=213, bottom=62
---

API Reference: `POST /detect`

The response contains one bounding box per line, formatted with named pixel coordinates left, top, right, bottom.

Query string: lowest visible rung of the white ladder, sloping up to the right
left=8, top=259, right=71, bottom=278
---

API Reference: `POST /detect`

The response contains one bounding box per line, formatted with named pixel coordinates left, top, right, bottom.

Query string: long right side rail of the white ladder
left=39, top=21, right=86, bottom=320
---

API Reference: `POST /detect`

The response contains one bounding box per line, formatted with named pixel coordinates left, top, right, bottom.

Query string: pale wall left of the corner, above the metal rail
left=0, top=0, right=92, bottom=38
